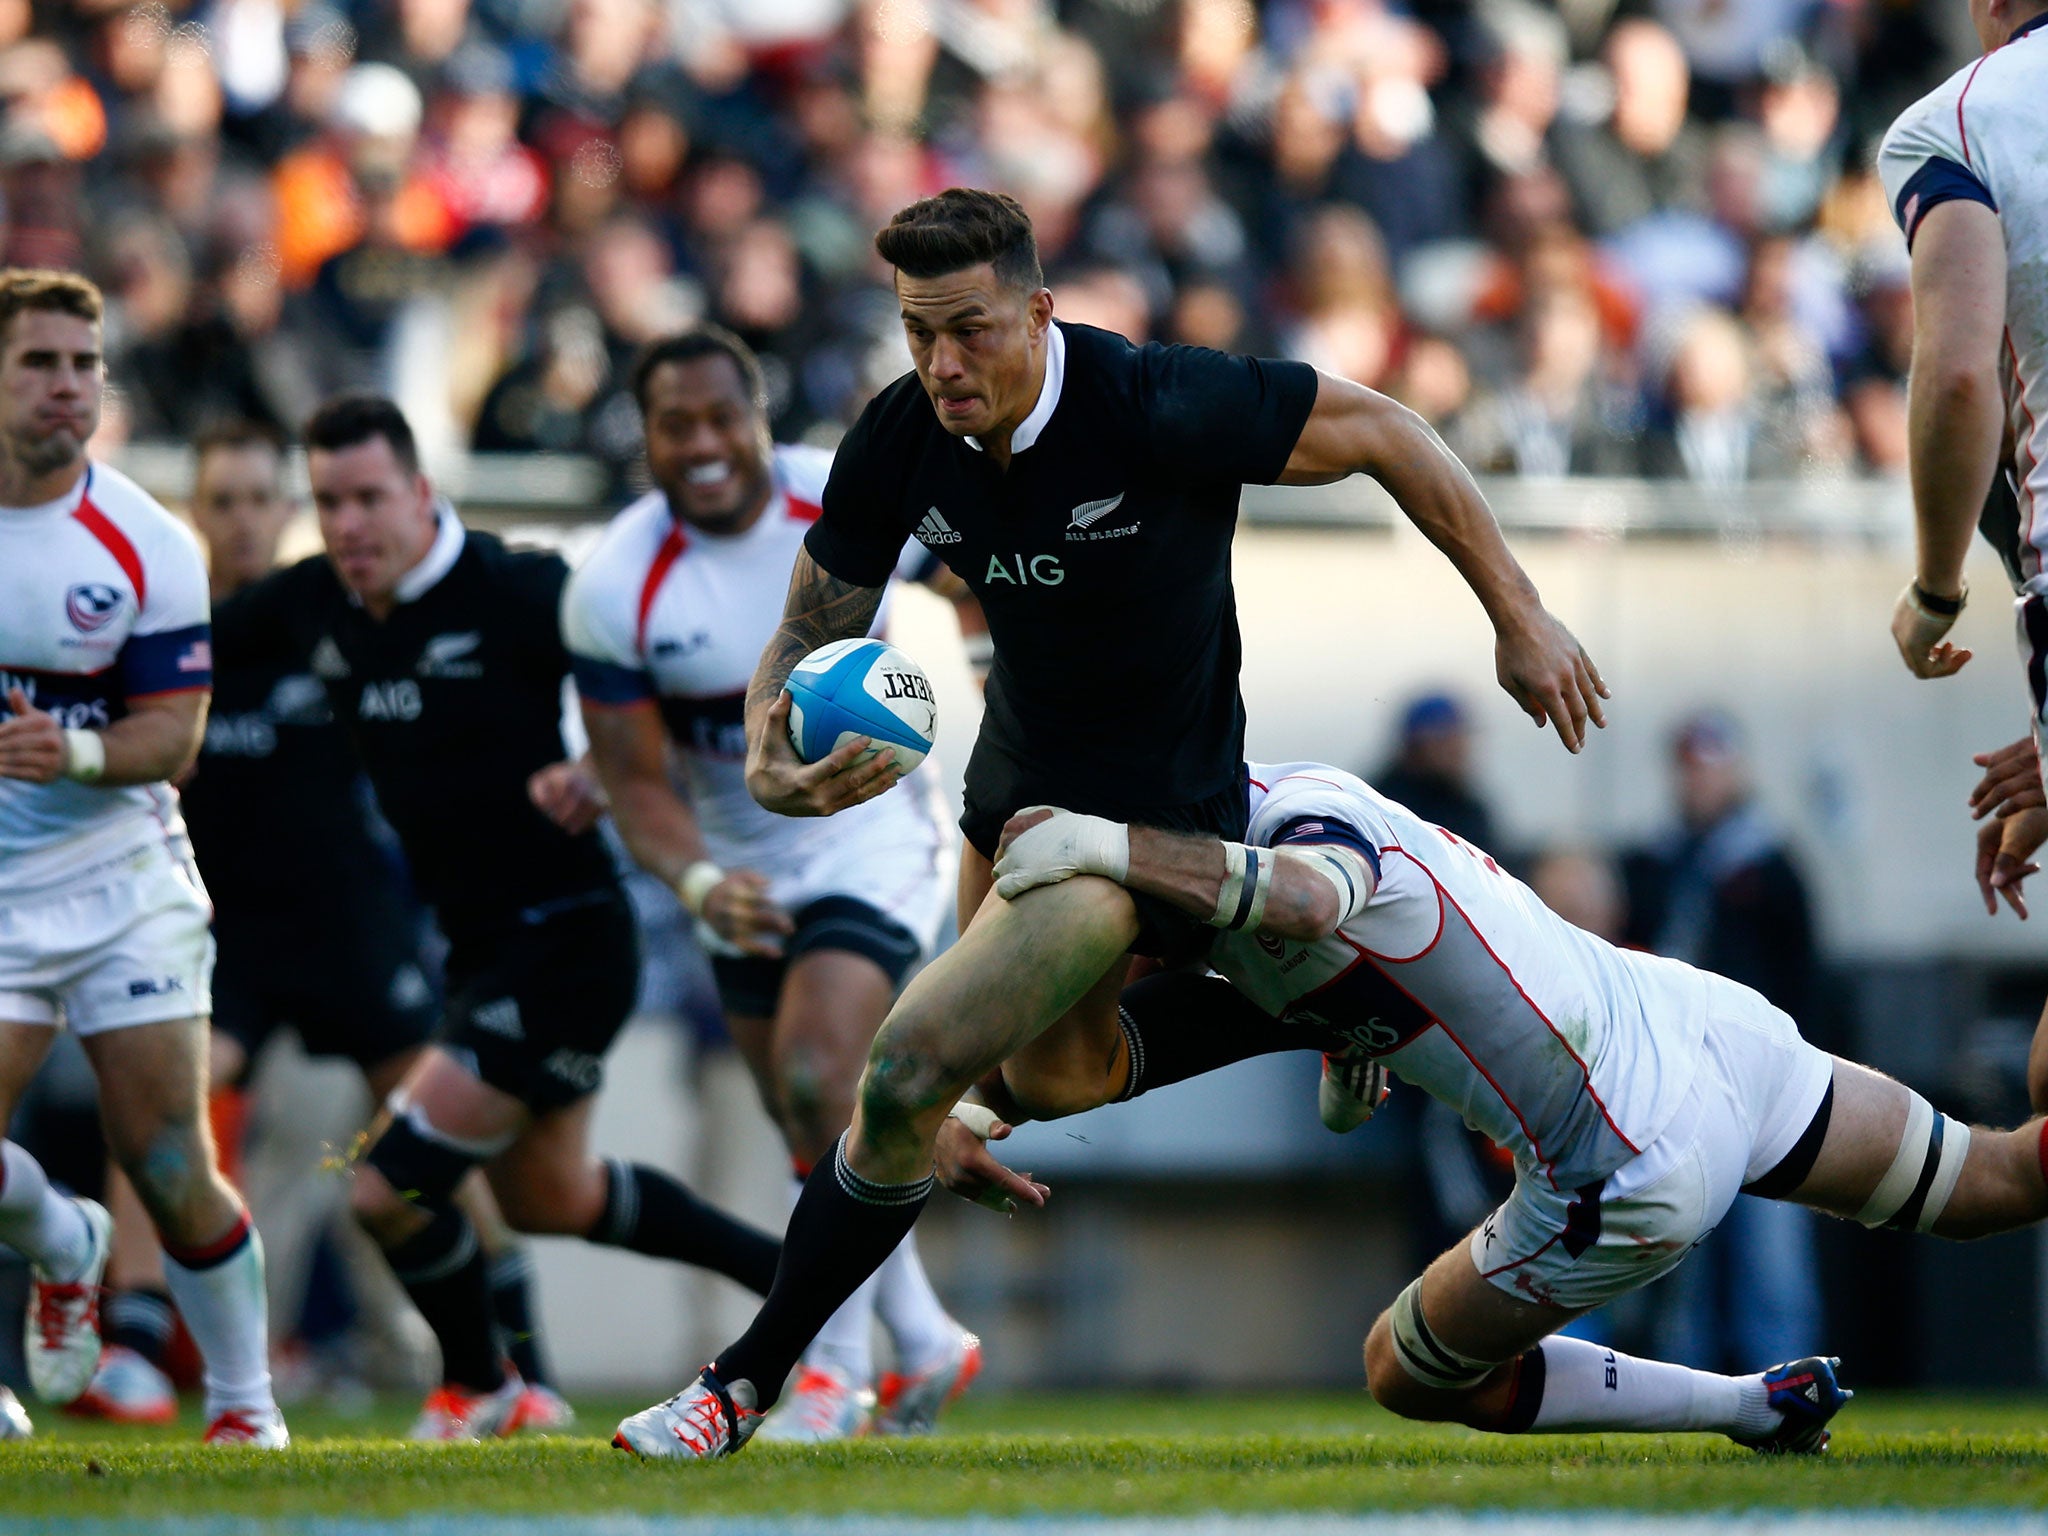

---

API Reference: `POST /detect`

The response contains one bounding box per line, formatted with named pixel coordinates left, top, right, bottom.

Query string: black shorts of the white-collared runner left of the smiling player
left=436, top=889, right=639, bottom=1114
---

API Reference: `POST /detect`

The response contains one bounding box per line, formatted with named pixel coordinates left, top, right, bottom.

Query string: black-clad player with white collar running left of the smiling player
left=221, top=397, right=776, bottom=1438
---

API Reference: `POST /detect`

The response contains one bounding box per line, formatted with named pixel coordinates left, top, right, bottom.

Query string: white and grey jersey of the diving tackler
left=1210, top=764, right=1733, bottom=1190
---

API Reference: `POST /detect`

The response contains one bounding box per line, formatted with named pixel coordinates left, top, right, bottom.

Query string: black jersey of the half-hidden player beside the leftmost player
left=180, top=592, right=397, bottom=922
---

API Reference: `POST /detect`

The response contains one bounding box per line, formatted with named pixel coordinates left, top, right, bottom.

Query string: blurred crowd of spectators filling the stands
left=0, top=0, right=1974, bottom=487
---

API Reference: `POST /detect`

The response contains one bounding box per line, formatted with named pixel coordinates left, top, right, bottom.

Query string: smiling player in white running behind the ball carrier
left=563, top=328, right=981, bottom=1442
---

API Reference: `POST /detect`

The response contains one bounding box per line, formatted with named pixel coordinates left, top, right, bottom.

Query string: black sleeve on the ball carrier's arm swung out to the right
left=1137, top=342, right=1317, bottom=485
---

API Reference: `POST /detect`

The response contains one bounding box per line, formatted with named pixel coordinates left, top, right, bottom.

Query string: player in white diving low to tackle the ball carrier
left=958, top=764, right=2048, bottom=1452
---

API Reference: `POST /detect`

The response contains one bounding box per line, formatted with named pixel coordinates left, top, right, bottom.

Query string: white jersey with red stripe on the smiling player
left=561, top=446, right=942, bottom=903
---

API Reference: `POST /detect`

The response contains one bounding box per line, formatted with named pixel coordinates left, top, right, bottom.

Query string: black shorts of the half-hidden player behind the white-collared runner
left=213, top=909, right=440, bottom=1071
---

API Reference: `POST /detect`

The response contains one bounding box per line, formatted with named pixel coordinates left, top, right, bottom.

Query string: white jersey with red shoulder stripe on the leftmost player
left=0, top=463, right=213, bottom=891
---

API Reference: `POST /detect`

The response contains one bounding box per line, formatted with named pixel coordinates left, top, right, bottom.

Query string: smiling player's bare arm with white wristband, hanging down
left=582, top=698, right=795, bottom=954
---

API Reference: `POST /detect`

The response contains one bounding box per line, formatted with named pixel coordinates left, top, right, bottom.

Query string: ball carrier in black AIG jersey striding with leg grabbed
left=614, top=188, right=1606, bottom=1456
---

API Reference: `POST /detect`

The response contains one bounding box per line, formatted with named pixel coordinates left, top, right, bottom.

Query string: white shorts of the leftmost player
left=0, top=831, right=213, bottom=1034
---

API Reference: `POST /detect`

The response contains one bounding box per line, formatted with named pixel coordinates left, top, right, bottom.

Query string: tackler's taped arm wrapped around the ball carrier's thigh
left=995, top=805, right=1374, bottom=944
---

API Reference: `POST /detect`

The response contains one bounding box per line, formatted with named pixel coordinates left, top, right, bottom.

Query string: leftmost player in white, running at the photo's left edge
left=0, top=270, right=287, bottom=1446
